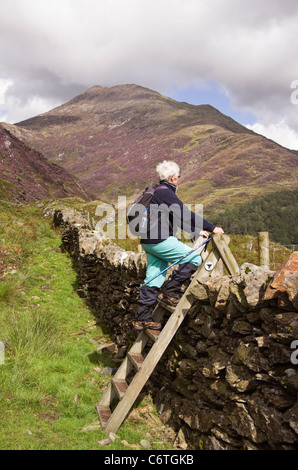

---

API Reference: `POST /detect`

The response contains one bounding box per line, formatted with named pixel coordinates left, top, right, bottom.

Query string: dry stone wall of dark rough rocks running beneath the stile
left=54, top=209, right=298, bottom=450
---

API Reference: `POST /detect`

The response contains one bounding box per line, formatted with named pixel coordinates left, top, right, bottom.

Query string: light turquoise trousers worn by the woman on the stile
left=142, top=237, right=202, bottom=288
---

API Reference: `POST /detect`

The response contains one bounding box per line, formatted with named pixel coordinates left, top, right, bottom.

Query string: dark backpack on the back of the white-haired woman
left=126, top=184, right=169, bottom=236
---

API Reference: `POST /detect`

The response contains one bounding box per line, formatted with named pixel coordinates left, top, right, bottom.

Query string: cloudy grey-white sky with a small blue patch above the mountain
left=0, top=0, right=298, bottom=149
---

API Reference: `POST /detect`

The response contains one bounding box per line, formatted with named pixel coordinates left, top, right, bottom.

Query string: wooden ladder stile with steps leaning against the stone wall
left=96, top=235, right=239, bottom=433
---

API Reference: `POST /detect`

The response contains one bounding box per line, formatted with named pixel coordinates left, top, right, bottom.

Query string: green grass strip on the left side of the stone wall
left=0, top=203, right=175, bottom=450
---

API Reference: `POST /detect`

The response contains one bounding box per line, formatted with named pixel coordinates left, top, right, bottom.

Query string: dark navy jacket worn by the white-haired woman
left=141, top=181, right=215, bottom=244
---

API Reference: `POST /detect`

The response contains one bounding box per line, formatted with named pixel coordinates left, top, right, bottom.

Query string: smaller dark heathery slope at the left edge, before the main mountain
left=0, top=124, right=90, bottom=203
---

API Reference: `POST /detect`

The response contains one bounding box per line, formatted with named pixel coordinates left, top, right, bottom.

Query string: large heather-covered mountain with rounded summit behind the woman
left=7, top=85, right=298, bottom=212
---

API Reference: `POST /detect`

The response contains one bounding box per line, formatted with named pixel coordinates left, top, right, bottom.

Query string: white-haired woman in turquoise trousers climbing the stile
left=134, top=160, right=224, bottom=331
